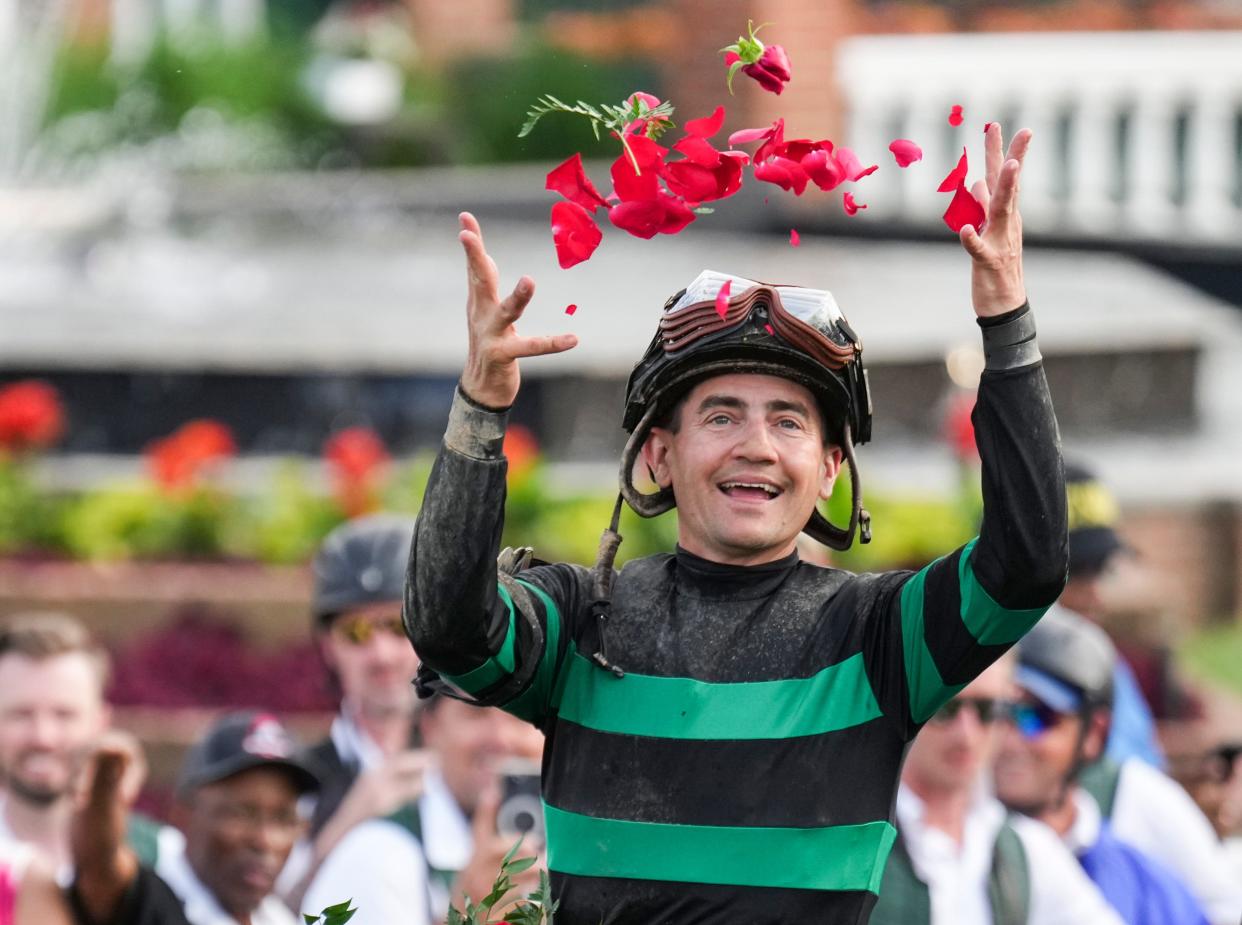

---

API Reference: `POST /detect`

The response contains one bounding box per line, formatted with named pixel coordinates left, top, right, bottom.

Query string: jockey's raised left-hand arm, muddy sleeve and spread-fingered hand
left=402, top=212, right=578, bottom=719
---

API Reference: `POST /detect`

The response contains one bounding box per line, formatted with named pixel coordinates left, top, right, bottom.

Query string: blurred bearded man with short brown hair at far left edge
left=0, top=613, right=109, bottom=883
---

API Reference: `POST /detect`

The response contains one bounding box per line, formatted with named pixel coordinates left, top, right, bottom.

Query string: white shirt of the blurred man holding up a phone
left=302, top=767, right=474, bottom=925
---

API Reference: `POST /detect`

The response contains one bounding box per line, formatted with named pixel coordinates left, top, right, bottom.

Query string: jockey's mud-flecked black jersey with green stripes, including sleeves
left=405, top=335, right=1066, bottom=925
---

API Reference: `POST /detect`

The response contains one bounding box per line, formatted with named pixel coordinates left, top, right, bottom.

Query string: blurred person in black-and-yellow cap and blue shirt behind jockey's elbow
left=1058, top=462, right=1165, bottom=769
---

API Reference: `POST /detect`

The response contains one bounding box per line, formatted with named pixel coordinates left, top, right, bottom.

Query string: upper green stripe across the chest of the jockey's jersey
left=560, top=653, right=882, bottom=740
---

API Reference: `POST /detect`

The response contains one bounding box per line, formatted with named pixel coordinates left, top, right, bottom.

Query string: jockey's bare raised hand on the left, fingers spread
left=457, top=212, right=578, bottom=408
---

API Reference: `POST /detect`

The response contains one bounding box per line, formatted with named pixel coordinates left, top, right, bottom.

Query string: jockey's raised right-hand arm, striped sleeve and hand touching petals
left=895, top=123, right=1068, bottom=730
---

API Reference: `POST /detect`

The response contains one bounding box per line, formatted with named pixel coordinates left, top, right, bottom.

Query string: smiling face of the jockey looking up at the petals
left=642, top=374, right=841, bottom=565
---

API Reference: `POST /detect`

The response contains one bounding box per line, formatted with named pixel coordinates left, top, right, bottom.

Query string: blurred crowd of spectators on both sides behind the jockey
left=0, top=467, right=1242, bottom=925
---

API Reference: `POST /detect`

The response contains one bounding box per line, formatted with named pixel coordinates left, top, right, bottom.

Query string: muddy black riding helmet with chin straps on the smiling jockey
left=620, top=271, right=871, bottom=549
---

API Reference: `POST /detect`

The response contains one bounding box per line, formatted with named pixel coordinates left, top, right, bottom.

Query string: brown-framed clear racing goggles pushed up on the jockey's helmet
left=660, top=269, right=862, bottom=370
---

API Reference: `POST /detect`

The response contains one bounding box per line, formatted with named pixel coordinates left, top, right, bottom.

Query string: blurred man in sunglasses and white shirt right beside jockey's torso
left=871, top=654, right=1120, bottom=925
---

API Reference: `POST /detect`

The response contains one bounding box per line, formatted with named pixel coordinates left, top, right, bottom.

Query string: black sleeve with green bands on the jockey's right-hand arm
left=868, top=307, right=1068, bottom=736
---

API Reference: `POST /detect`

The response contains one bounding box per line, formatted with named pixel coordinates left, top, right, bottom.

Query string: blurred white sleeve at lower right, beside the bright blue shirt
left=1109, top=759, right=1242, bottom=925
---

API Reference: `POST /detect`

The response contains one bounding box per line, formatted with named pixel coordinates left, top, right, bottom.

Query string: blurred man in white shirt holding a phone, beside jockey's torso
left=303, top=694, right=543, bottom=925
